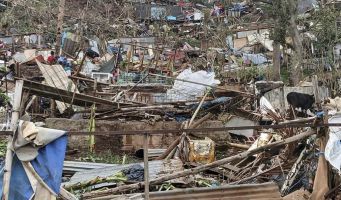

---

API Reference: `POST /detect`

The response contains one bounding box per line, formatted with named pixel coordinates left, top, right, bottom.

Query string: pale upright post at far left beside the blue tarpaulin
left=2, top=80, right=24, bottom=200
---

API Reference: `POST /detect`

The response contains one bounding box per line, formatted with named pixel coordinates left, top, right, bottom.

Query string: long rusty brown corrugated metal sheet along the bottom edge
left=94, top=183, right=282, bottom=200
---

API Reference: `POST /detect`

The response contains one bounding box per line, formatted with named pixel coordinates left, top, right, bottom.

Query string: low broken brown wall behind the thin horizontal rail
left=46, top=118, right=230, bottom=152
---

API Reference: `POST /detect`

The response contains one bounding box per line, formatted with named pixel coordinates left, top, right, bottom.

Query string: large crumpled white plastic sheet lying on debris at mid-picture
left=167, top=69, right=220, bottom=101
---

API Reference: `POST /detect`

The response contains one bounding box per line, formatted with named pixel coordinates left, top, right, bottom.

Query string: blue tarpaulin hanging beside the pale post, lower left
left=0, top=135, right=67, bottom=200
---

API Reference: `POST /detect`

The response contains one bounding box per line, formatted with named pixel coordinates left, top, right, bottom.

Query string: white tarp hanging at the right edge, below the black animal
left=324, top=113, right=341, bottom=171
